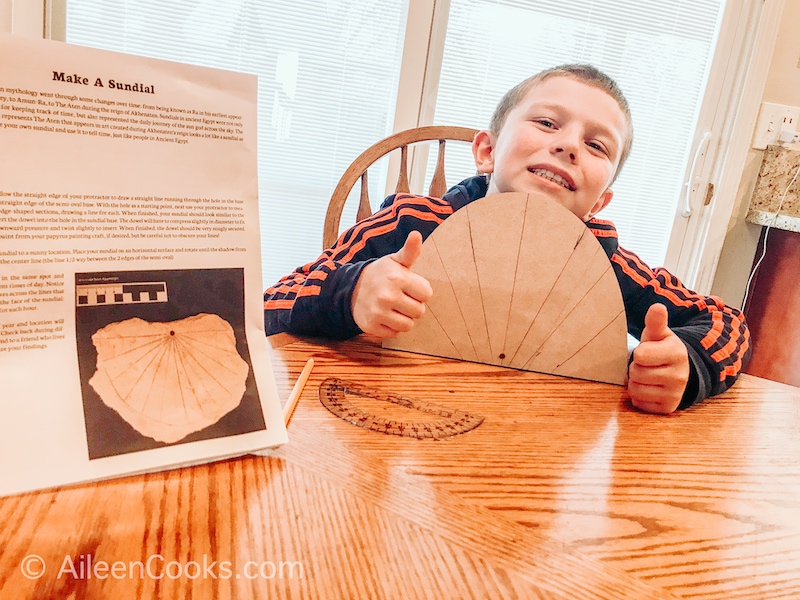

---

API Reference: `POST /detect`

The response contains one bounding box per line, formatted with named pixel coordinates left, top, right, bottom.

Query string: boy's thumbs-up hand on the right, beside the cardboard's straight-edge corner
left=628, top=304, right=689, bottom=414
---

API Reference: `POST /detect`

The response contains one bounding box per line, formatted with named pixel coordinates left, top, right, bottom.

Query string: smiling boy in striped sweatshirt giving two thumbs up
left=264, top=65, right=750, bottom=414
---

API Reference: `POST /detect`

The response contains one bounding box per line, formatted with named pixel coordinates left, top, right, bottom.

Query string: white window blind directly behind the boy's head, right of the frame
left=426, top=0, right=724, bottom=266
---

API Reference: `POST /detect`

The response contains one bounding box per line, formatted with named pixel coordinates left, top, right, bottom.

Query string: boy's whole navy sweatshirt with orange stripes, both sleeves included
left=264, top=176, right=750, bottom=408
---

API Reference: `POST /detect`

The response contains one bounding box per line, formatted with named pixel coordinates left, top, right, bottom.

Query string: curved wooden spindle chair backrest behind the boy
left=322, top=126, right=478, bottom=250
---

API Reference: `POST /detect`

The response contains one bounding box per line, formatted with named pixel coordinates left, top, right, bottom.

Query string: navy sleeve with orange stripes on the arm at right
left=611, top=247, right=750, bottom=408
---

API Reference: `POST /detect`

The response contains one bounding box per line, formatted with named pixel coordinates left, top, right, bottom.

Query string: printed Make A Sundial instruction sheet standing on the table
left=0, top=34, right=286, bottom=495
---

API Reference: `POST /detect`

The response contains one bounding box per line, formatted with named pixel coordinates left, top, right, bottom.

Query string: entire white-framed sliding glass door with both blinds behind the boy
left=50, top=0, right=769, bottom=291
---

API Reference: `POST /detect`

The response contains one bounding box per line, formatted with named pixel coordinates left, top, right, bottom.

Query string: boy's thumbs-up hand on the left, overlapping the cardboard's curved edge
left=350, top=231, right=433, bottom=338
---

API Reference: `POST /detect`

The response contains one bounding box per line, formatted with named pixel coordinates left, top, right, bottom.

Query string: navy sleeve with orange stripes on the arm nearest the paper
left=264, top=194, right=453, bottom=339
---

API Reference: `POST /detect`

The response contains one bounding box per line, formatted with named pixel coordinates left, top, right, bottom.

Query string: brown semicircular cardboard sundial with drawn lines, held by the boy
left=383, top=193, right=628, bottom=385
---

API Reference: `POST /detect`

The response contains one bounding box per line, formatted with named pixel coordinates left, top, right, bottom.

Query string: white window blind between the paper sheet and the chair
left=66, top=0, right=405, bottom=287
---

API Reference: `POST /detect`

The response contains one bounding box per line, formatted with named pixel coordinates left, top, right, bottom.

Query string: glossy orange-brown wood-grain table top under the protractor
left=0, top=335, right=800, bottom=600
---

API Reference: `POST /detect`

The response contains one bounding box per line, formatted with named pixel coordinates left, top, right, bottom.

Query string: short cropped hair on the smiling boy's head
left=489, top=64, right=633, bottom=183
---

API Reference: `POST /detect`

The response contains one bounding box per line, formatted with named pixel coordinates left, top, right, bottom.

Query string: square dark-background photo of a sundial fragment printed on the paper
left=75, top=269, right=266, bottom=459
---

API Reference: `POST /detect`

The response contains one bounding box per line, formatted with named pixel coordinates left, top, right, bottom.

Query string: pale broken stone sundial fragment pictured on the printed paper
left=89, top=314, right=250, bottom=444
